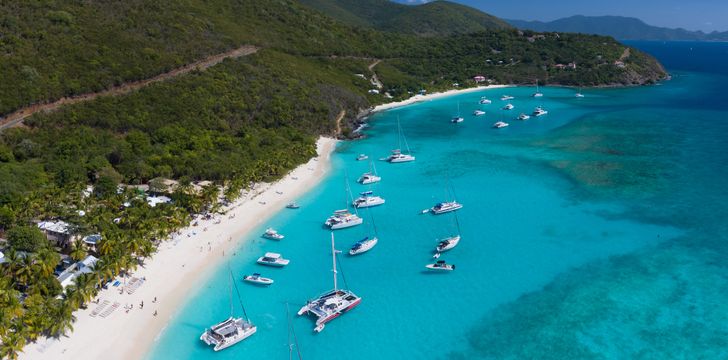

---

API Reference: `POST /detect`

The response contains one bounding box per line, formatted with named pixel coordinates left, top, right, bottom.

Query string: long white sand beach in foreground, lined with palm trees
left=20, top=137, right=337, bottom=360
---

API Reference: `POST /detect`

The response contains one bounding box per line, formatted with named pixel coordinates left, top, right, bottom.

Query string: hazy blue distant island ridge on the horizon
left=506, top=15, right=728, bottom=41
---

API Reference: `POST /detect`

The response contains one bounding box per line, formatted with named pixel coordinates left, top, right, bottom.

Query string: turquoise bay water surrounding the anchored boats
left=148, top=43, right=728, bottom=359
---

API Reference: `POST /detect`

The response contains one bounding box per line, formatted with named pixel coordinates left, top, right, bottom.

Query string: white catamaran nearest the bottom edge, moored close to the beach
left=200, top=271, right=258, bottom=351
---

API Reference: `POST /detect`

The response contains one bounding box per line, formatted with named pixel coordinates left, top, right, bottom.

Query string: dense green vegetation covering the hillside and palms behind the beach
left=0, top=0, right=664, bottom=357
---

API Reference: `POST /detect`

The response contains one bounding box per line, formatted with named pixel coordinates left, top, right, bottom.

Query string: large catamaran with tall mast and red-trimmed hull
left=298, top=232, right=361, bottom=332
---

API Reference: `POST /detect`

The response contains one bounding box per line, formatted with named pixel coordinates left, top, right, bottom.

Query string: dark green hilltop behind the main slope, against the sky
left=301, top=0, right=511, bottom=36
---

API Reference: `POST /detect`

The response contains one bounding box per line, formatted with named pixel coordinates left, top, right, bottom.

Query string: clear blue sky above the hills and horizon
left=398, top=0, right=728, bottom=32
